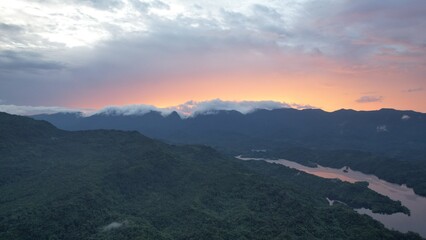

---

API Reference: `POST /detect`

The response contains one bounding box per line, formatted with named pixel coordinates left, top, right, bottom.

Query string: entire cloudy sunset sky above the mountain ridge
left=0, top=0, right=426, bottom=114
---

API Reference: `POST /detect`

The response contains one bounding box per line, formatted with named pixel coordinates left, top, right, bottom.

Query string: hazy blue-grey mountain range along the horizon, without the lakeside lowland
left=33, top=109, right=426, bottom=160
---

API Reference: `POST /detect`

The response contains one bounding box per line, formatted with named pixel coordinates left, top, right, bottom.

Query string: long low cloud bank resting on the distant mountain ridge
left=0, top=99, right=314, bottom=118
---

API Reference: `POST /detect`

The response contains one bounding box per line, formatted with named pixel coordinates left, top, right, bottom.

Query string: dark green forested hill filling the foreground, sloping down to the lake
left=0, top=113, right=420, bottom=240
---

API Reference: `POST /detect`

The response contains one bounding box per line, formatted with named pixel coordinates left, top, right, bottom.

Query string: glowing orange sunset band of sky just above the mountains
left=67, top=67, right=426, bottom=112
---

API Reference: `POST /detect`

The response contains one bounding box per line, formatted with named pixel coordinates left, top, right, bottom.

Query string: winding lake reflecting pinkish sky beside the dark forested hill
left=237, top=157, right=426, bottom=237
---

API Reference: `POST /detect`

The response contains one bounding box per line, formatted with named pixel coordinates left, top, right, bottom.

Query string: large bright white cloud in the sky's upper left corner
left=0, top=0, right=144, bottom=50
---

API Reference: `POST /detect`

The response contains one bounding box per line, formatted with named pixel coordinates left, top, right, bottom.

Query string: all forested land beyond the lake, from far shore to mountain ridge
left=33, top=109, right=426, bottom=196
